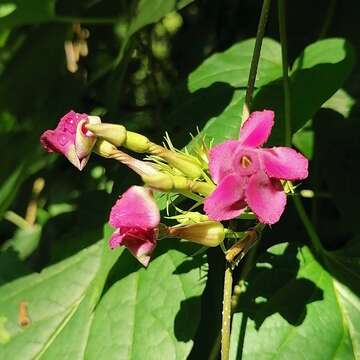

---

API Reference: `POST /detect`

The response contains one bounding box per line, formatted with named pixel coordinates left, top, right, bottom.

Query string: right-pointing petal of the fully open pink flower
left=261, top=147, right=308, bottom=180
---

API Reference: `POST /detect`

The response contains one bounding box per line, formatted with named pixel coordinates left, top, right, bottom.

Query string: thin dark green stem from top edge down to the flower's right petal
left=278, top=0, right=291, bottom=146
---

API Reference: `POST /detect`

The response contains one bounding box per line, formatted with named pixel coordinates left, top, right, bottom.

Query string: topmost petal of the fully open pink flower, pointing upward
left=239, top=110, right=274, bottom=147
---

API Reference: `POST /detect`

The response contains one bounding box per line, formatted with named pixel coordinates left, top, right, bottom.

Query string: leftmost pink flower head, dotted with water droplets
left=40, top=111, right=101, bottom=170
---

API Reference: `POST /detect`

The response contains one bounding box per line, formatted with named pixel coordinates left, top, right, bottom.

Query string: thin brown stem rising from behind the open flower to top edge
left=242, top=0, right=271, bottom=124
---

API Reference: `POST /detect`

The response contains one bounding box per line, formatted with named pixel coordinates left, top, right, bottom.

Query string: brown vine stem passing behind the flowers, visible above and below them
left=221, top=0, right=271, bottom=360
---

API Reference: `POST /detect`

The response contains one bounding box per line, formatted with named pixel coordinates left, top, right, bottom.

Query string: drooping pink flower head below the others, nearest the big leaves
left=109, top=186, right=160, bottom=266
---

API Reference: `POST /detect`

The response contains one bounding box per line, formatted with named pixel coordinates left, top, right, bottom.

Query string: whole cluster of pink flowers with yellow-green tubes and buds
left=40, top=110, right=308, bottom=266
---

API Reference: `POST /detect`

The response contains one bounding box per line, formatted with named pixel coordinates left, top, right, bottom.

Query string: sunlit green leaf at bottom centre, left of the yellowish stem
left=85, top=240, right=205, bottom=360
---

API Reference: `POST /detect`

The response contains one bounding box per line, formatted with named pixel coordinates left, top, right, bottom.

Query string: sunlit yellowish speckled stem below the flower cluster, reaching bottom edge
left=221, top=263, right=233, bottom=360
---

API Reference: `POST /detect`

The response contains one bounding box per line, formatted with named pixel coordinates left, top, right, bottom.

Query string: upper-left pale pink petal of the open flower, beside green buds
left=209, top=140, right=239, bottom=184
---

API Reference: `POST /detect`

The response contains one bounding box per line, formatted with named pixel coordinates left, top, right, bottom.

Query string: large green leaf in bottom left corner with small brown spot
left=0, top=225, right=120, bottom=359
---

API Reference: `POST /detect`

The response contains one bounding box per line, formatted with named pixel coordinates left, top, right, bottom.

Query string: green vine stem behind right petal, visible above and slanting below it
left=278, top=0, right=324, bottom=254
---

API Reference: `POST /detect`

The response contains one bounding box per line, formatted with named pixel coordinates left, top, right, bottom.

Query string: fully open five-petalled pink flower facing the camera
left=204, top=110, right=308, bottom=224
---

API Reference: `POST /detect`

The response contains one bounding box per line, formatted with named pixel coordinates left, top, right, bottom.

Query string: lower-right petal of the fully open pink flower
left=245, top=171, right=286, bottom=224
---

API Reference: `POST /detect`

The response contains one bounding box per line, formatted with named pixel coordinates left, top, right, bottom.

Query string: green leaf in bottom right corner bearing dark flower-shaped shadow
left=231, top=244, right=360, bottom=360
